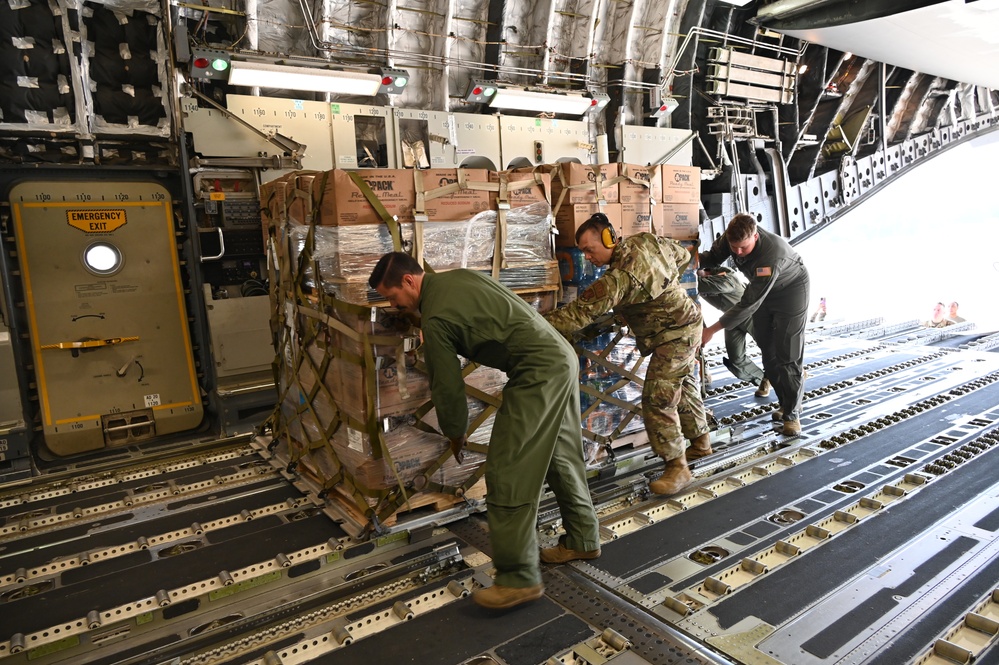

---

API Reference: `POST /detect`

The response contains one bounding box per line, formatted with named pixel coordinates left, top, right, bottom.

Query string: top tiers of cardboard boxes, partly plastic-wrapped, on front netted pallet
left=269, top=169, right=556, bottom=304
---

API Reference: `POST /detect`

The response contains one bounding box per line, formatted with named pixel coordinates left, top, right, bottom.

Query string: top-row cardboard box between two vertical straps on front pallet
left=407, top=169, right=496, bottom=222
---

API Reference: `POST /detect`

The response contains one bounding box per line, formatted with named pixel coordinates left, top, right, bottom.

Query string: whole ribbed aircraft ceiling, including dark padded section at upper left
left=0, top=0, right=999, bottom=240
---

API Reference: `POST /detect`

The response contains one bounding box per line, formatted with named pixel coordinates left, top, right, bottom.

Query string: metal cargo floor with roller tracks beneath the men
left=0, top=339, right=999, bottom=665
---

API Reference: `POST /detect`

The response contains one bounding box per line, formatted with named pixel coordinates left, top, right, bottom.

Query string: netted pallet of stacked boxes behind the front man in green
left=263, top=169, right=558, bottom=534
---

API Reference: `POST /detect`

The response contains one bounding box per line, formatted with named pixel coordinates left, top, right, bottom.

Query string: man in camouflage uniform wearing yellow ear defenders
left=545, top=213, right=712, bottom=494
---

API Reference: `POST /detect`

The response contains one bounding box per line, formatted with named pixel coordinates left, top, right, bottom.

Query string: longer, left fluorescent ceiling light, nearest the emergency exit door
left=229, top=60, right=382, bottom=96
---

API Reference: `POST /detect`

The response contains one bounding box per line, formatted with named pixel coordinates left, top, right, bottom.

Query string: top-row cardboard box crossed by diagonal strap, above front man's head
left=312, top=169, right=416, bottom=226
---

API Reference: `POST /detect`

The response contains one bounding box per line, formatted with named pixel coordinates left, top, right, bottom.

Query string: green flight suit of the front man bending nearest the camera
left=419, top=270, right=600, bottom=588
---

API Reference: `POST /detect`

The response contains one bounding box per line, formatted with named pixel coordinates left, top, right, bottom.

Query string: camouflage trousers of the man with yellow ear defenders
left=642, top=322, right=710, bottom=460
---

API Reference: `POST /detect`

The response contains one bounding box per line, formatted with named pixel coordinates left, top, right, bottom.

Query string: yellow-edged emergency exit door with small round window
left=10, top=182, right=203, bottom=455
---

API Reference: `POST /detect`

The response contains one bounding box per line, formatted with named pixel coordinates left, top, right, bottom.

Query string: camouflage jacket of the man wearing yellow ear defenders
left=545, top=233, right=702, bottom=355
